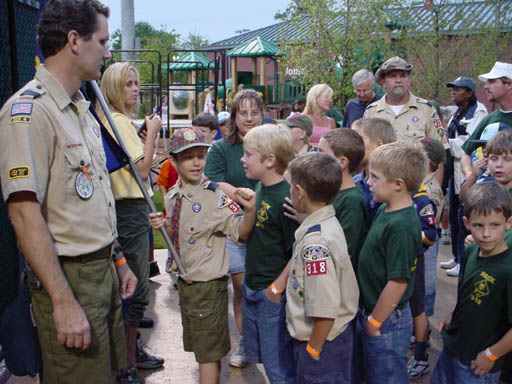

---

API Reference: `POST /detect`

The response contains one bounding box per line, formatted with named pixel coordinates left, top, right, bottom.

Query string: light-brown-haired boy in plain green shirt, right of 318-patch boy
left=354, top=142, right=427, bottom=384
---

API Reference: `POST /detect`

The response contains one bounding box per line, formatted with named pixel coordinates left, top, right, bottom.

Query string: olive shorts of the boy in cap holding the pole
left=178, top=277, right=231, bottom=364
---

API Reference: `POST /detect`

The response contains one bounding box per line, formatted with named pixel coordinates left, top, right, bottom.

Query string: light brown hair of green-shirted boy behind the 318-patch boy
left=370, top=141, right=428, bottom=192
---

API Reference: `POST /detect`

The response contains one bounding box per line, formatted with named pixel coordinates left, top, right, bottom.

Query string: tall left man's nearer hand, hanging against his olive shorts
left=53, top=299, right=91, bottom=351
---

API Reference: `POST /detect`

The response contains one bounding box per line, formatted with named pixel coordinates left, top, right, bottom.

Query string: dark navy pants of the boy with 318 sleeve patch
left=293, top=323, right=354, bottom=384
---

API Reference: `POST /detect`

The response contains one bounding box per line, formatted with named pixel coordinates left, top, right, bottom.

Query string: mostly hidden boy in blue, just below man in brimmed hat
left=351, top=117, right=396, bottom=220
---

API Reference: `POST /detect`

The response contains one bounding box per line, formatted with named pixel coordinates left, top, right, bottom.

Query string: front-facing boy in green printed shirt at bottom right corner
left=431, top=182, right=512, bottom=384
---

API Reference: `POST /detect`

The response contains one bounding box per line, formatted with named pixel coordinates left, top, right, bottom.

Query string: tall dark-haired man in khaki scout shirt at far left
left=0, top=0, right=136, bottom=384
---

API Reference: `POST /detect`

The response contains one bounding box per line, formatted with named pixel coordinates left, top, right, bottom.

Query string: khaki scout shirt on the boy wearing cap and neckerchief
left=165, top=179, right=243, bottom=281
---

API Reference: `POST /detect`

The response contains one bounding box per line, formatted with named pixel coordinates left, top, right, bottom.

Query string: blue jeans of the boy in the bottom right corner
left=430, top=348, right=501, bottom=384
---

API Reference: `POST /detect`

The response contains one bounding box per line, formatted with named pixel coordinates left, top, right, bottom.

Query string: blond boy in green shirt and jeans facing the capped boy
left=241, top=124, right=297, bottom=384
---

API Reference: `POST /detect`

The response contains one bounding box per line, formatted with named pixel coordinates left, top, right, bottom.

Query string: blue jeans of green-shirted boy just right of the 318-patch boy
left=352, top=304, right=413, bottom=384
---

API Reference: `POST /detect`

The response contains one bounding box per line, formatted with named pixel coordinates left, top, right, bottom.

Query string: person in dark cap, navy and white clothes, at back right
left=440, top=77, right=487, bottom=276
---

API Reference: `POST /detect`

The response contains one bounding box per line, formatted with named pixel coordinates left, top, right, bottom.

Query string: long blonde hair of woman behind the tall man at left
left=96, top=62, right=139, bottom=118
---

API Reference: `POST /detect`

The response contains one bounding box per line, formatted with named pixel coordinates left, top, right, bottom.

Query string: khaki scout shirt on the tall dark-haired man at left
left=0, top=66, right=117, bottom=256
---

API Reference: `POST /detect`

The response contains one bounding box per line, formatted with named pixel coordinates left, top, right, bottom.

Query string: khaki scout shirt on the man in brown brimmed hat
left=364, top=92, right=444, bottom=143
